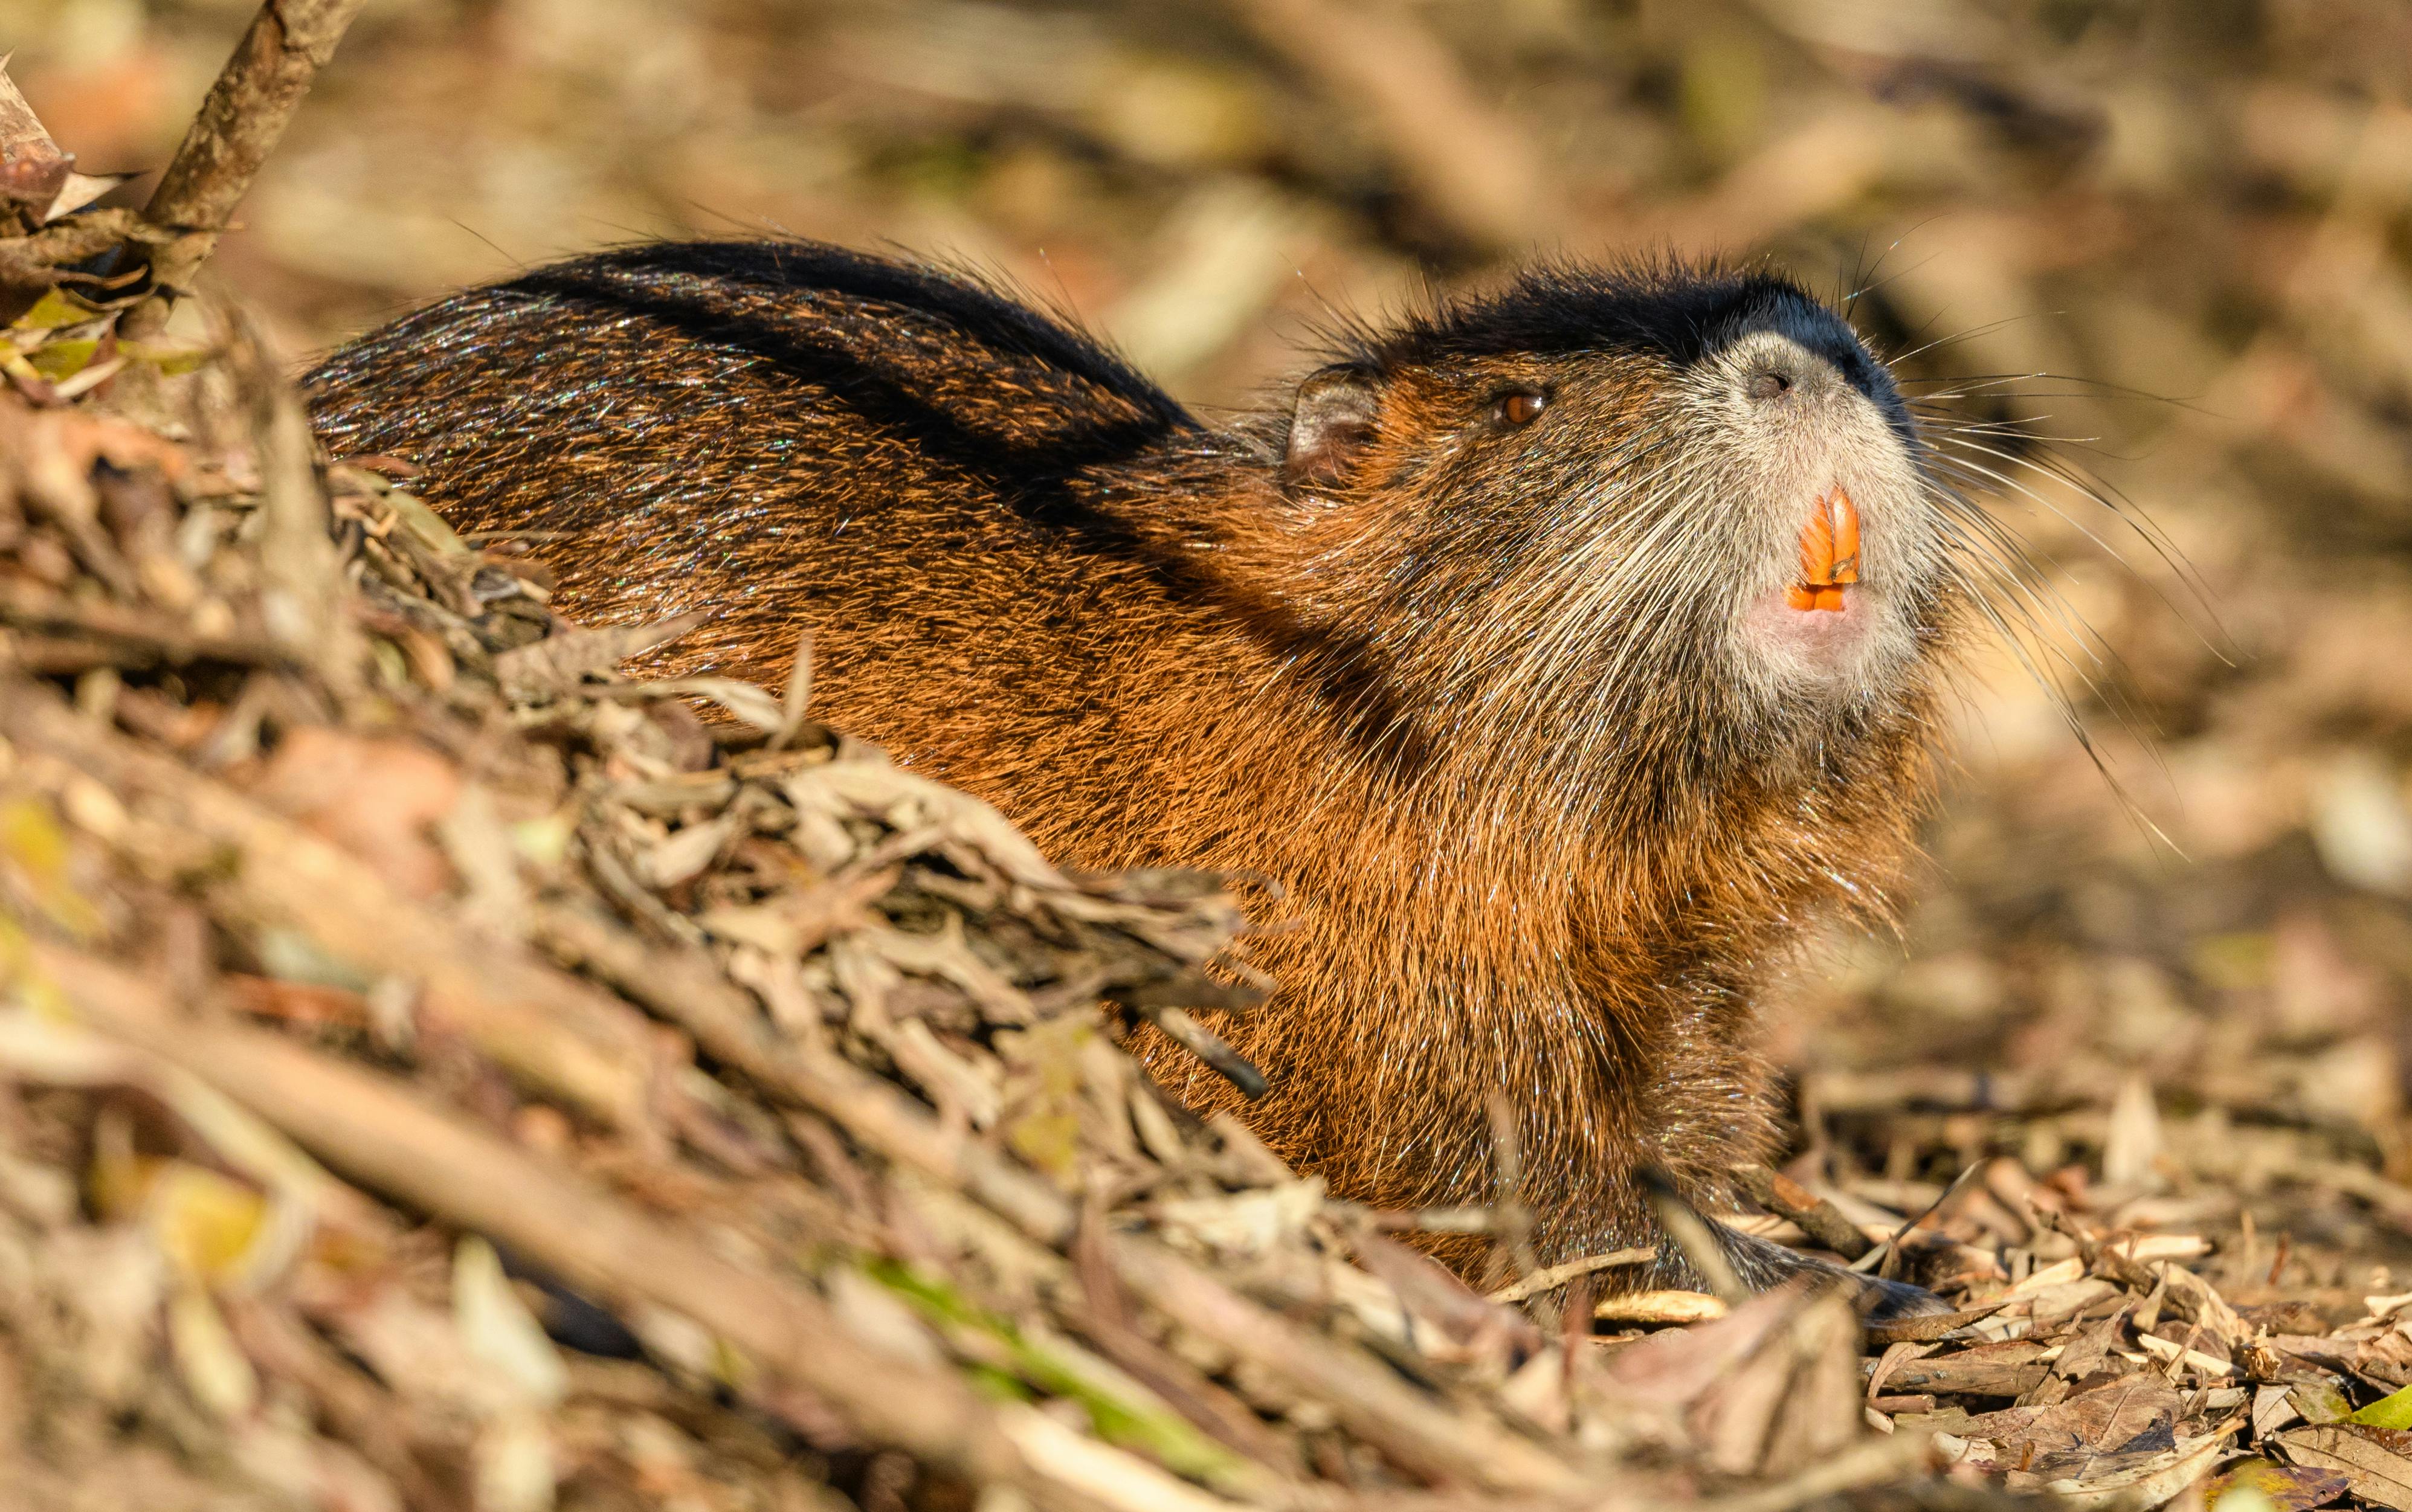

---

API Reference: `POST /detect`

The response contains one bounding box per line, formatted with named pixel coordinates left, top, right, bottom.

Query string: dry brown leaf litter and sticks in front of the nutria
left=0, top=24, right=2412, bottom=1512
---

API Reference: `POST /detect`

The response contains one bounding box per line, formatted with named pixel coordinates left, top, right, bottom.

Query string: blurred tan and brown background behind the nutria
left=14, top=0, right=2412, bottom=1300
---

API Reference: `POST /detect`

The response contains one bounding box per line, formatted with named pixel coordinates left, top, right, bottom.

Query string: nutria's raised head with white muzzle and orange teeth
left=1269, top=268, right=1965, bottom=829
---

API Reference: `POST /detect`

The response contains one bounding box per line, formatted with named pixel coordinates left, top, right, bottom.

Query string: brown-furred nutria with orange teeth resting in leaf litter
left=309, top=241, right=1975, bottom=1305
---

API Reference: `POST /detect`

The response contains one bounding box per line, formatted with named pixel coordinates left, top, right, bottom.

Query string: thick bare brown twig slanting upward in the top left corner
left=121, top=0, right=364, bottom=340
